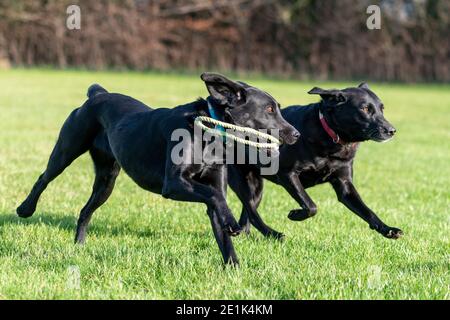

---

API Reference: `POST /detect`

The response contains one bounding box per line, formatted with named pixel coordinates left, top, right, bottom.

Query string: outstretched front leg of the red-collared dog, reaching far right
left=330, top=172, right=403, bottom=239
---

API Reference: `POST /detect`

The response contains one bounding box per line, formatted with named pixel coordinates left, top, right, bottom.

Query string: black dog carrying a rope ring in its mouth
left=17, top=73, right=299, bottom=263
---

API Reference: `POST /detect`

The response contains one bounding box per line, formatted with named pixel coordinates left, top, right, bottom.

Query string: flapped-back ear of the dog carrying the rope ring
left=200, top=72, right=245, bottom=107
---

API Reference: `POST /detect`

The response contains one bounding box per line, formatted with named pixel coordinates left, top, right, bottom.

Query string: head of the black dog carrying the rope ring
left=201, top=72, right=300, bottom=144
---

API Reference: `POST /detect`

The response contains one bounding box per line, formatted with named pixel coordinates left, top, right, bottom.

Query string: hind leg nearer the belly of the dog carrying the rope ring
left=75, top=148, right=120, bottom=244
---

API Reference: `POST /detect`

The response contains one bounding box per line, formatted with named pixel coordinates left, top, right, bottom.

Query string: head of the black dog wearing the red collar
left=308, top=83, right=396, bottom=142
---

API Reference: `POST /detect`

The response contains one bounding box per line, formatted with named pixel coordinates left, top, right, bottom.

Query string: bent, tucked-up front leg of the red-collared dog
left=279, top=172, right=317, bottom=221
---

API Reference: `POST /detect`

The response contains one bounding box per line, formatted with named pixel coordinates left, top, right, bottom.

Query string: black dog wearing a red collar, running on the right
left=228, top=83, right=402, bottom=239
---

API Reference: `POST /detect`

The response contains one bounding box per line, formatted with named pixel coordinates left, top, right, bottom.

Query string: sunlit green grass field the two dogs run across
left=0, top=70, right=450, bottom=299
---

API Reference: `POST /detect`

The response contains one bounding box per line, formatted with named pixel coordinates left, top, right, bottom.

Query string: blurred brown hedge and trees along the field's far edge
left=0, top=0, right=450, bottom=81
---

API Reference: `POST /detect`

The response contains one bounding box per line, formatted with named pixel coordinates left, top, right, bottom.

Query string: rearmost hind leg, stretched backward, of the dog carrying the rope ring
left=17, top=108, right=95, bottom=218
